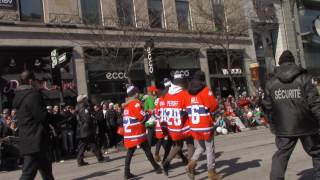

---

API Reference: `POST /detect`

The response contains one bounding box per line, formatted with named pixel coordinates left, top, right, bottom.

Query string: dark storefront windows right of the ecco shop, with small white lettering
left=207, top=50, right=248, bottom=97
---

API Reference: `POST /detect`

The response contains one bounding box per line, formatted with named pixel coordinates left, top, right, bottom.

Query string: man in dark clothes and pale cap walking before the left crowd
left=76, top=95, right=104, bottom=166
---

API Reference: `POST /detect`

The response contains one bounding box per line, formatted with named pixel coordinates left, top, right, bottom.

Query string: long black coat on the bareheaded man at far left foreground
left=13, top=85, right=49, bottom=154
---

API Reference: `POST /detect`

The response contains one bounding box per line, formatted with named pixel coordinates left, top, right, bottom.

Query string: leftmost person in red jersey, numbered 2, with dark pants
left=123, top=85, right=162, bottom=179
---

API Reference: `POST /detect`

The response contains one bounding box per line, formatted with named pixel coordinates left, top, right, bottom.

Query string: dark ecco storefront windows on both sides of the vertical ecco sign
left=86, top=49, right=200, bottom=103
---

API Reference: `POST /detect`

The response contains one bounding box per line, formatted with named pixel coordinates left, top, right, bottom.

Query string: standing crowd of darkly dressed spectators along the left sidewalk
left=0, top=102, right=122, bottom=169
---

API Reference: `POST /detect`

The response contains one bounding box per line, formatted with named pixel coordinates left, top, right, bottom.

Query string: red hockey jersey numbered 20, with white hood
left=164, top=85, right=190, bottom=141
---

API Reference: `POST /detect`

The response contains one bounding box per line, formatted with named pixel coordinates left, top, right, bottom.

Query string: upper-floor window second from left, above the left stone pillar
left=81, top=0, right=101, bottom=25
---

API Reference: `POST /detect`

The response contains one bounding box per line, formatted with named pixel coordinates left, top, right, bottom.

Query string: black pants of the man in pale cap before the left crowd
left=77, top=138, right=103, bottom=164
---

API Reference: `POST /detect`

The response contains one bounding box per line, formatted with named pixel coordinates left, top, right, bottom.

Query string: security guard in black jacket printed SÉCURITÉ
left=263, top=51, right=320, bottom=180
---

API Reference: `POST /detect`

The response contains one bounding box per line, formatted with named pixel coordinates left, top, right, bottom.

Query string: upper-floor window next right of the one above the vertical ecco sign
left=176, top=0, right=191, bottom=30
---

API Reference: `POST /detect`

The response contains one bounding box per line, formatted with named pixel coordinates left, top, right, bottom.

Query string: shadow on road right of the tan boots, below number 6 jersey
left=198, top=158, right=262, bottom=180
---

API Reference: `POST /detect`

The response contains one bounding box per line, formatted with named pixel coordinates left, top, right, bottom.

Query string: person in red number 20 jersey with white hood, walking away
left=163, top=74, right=194, bottom=175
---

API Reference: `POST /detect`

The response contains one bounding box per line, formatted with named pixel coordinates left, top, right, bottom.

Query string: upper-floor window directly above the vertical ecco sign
left=148, top=0, right=164, bottom=28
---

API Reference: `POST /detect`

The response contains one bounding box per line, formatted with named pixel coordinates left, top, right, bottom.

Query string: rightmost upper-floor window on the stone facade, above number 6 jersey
left=212, top=0, right=225, bottom=31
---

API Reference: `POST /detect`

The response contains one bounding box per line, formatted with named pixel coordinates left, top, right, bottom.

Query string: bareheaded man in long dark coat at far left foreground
left=13, top=71, right=54, bottom=180
